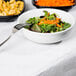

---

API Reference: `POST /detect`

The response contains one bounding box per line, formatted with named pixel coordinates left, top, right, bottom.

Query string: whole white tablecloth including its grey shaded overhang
left=0, top=0, right=76, bottom=76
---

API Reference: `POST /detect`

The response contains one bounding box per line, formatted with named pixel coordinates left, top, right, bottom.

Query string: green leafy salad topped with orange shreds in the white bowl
left=24, top=11, right=71, bottom=33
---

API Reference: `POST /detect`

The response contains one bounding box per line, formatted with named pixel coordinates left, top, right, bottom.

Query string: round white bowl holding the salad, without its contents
left=18, top=9, right=75, bottom=43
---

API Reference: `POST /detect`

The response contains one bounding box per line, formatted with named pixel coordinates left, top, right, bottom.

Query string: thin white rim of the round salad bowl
left=17, top=8, right=75, bottom=34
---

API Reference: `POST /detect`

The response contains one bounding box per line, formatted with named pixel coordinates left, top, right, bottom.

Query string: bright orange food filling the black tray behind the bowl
left=36, top=0, right=75, bottom=7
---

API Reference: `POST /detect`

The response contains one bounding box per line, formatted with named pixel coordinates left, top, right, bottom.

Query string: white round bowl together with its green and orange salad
left=18, top=9, right=75, bottom=44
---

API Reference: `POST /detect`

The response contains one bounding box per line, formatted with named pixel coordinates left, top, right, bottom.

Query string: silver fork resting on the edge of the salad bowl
left=0, top=23, right=30, bottom=46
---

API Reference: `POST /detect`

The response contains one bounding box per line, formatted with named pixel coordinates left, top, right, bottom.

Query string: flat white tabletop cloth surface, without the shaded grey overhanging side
left=0, top=0, right=76, bottom=76
